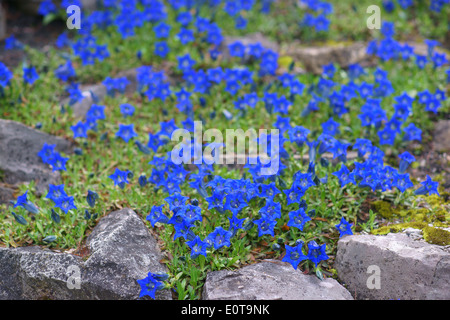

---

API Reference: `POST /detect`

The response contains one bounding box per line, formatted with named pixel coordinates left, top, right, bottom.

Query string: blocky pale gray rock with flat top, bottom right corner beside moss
left=334, top=232, right=450, bottom=300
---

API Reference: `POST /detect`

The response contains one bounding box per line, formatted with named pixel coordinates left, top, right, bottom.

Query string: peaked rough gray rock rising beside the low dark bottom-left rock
left=84, top=209, right=171, bottom=300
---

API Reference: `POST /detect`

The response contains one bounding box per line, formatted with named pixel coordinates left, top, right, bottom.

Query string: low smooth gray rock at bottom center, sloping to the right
left=202, top=260, right=353, bottom=300
